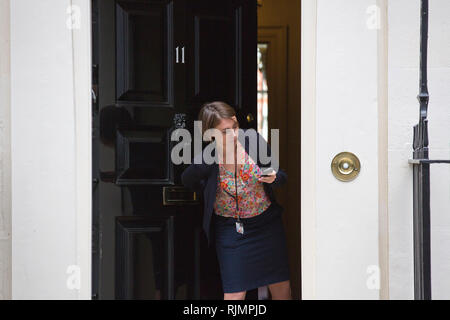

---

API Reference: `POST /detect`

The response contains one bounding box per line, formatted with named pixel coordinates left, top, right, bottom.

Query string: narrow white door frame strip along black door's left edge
left=71, top=0, right=92, bottom=300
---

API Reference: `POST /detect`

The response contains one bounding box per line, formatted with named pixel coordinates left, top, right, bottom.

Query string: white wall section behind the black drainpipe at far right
left=388, top=0, right=450, bottom=299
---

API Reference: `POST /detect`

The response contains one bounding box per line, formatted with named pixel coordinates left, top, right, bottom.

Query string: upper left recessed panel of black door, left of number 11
left=115, top=1, right=174, bottom=107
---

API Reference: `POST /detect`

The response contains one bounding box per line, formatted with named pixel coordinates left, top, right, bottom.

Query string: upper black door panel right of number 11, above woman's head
left=186, top=0, right=238, bottom=105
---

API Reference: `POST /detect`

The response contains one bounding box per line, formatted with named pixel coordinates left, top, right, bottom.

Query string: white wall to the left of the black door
left=11, top=0, right=91, bottom=299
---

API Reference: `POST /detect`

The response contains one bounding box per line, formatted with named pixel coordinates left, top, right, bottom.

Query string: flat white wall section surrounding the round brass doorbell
left=302, top=0, right=380, bottom=299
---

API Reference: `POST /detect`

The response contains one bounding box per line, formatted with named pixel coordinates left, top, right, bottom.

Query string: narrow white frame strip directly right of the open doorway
left=300, top=0, right=317, bottom=300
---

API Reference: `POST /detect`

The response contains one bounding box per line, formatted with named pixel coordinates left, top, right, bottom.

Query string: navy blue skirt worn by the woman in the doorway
left=213, top=203, right=289, bottom=293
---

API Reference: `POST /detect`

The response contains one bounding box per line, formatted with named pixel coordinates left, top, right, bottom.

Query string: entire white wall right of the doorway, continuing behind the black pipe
left=302, top=0, right=450, bottom=299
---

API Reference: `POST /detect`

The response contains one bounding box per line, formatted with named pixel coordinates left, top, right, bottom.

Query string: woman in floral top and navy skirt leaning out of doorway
left=181, top=101, right=291, bottom=300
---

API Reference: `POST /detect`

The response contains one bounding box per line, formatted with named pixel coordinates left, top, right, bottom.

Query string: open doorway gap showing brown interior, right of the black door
left=258, top=0, right=301, bottom=299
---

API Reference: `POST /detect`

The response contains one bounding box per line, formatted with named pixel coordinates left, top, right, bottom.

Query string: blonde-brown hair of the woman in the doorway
left=198, top=101, right=236, bottom=134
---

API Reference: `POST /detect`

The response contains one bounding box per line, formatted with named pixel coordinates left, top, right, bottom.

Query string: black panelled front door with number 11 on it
left=92, top=0, right=257, bottom=299
